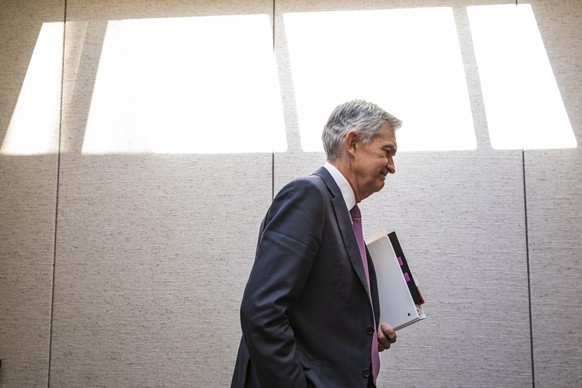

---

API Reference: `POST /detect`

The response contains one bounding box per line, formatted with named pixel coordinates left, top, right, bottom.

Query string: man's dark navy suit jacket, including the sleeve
left=232, top=167, right=379, bottom=388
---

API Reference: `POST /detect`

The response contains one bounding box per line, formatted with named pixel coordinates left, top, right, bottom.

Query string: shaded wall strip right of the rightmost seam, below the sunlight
left=526, top=149, right=582, bottom=387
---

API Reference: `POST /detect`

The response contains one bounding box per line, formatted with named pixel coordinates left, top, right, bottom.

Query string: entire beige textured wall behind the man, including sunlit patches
left=0, top=0, right=582, bottom=387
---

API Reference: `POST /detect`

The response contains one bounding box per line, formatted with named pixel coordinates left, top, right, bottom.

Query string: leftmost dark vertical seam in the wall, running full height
left=47, top=0, right=67, bottom=388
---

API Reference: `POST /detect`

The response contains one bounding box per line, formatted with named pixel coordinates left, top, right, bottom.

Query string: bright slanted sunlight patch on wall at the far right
left=467, top=4, right=577, bottom=149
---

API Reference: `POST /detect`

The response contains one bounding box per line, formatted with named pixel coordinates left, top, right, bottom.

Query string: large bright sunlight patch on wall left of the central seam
left=83, top=15, right=286, bottom=154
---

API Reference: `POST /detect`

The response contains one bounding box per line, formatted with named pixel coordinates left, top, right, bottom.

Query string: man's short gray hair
left=321, top=100, right=402, bottom=161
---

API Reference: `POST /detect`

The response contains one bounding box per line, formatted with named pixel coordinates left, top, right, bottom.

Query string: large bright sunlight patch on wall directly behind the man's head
left=284, top=7, right=477, bottom=151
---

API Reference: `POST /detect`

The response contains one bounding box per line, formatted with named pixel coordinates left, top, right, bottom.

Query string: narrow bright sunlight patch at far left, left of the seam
left=0, top=22, right=63, bottom=155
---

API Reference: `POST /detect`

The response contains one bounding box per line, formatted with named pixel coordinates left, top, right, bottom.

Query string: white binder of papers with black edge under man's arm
left=367, top=232, right=425, bottom=330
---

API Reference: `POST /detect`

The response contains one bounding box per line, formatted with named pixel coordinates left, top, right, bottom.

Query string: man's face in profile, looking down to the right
left=352, top=123, right=397, bottom=202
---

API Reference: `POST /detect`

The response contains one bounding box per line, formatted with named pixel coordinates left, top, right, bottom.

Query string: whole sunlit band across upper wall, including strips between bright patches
left=0, top=5, right=577, bottom=155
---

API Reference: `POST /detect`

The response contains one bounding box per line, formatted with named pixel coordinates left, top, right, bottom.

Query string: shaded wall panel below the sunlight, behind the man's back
left=51, top=155, right=271, bottom=387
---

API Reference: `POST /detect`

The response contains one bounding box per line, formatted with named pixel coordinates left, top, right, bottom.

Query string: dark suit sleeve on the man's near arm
left=241, top=180, right=324, bottom=387
